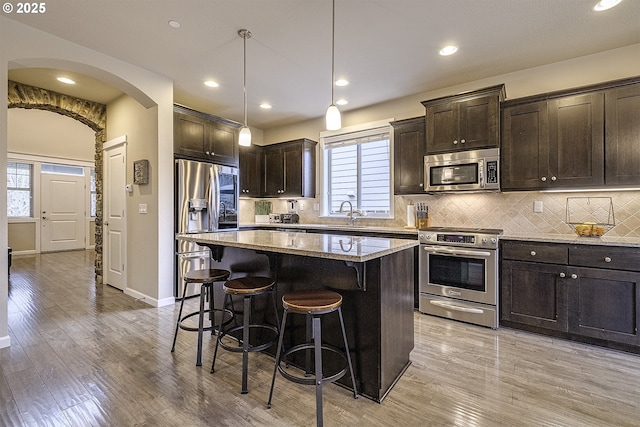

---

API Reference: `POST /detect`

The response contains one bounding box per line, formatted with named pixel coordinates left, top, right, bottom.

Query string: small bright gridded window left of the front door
left=7, top=162, right=33, bottom=218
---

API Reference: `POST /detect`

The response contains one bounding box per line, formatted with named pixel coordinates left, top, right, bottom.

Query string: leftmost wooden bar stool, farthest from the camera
left=171, top=268, right=234, bottom=366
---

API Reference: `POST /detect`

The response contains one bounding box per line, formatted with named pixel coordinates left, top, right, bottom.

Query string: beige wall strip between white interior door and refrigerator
left=107, top=95, right=159, bottom=295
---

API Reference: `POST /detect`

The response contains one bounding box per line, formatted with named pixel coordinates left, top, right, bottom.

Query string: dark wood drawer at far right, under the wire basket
left=569, top=245, right=640, bottom=271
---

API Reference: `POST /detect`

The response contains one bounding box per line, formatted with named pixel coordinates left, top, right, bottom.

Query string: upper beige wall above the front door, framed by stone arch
left=7, top=108, right=95, bottom=163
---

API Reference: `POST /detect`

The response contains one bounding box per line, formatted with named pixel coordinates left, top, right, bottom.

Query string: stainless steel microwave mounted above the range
left=424, top=148, right=500, bottom=192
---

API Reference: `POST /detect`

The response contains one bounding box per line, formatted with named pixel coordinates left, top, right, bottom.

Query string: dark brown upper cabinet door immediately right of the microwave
left=500, top=102, right=549, bottom=190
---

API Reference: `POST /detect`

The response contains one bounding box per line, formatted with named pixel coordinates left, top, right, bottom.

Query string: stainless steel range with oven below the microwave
left=418, top=227, right=502, bottom=329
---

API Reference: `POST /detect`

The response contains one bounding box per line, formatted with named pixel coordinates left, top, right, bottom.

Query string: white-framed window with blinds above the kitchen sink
left=320, top=121, right=393, bottom=218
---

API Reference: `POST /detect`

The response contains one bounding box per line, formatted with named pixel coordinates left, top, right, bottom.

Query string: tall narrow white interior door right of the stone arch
left=102, top=141, right=127, bottom=290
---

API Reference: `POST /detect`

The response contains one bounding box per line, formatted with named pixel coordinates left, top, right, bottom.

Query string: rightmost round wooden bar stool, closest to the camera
left=267, top=290, right=358, bottom=426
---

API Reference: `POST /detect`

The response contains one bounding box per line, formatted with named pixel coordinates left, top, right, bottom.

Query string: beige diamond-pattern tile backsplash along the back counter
left=240, top=191, right=640, bottom=237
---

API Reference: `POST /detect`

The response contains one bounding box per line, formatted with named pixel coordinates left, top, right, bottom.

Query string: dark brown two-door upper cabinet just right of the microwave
left=501, top=93, right=604, bottom=191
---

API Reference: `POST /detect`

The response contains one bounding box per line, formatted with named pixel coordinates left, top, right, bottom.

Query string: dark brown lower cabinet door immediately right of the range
left=500, top=261, right=567, bottom=331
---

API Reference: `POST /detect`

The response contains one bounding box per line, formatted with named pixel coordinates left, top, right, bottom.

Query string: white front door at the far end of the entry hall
left=40, top=174, right=86, bottom=252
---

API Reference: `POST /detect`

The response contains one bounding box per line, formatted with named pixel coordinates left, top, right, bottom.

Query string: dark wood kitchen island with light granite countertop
left=177, top=230, right=418, bottom=402
